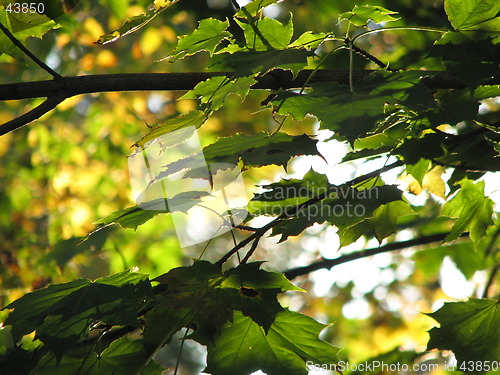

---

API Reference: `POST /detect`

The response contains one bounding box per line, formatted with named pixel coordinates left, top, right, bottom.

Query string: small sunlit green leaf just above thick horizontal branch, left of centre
left=169, top=18, right=231, bottom=61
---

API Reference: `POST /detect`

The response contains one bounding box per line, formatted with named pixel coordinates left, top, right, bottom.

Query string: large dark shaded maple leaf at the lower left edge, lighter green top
left=5, top=270, right=150, bottom=347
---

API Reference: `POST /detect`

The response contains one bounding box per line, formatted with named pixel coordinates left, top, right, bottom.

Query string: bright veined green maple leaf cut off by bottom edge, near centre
left=204, top=310, right=338, bottom=375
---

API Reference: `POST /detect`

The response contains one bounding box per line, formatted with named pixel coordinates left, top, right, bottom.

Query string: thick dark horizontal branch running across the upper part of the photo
left=0, top=69, right=494, bottom=100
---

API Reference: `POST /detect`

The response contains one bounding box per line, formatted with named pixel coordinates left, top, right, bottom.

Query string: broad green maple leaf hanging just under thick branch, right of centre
left=273, top=72, right=433, bottom=145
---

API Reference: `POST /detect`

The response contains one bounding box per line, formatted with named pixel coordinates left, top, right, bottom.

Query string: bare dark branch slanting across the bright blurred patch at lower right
left=284, top=233, right=469, bottom=280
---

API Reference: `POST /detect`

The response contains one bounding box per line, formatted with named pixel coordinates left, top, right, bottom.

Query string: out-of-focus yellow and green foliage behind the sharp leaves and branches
left=0, top=0, right=498, bottom=373
